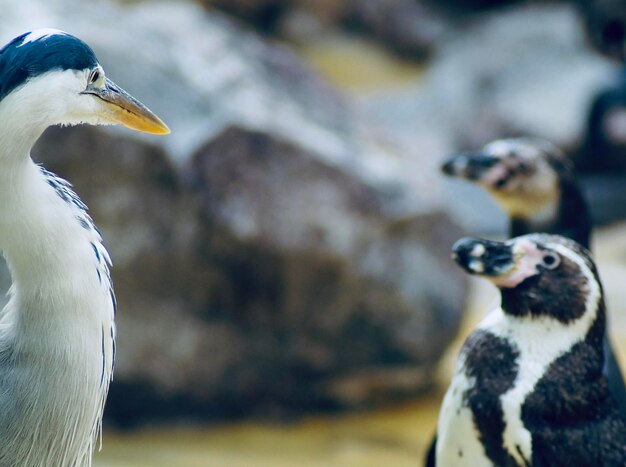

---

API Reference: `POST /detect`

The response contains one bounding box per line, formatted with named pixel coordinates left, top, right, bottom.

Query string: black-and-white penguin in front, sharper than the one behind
left=435, top=234, right=626, bottom=467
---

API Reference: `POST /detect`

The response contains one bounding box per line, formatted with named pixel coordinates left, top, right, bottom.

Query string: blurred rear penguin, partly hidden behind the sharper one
left=442, top=138, right=626, bottom=419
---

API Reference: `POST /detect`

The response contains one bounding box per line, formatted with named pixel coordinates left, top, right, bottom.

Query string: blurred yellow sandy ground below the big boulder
left=95, top=395, right=440, bottom=467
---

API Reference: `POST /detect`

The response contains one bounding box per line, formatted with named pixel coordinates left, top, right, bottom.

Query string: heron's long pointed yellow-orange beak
left=85, top=78, right=170, bottom=135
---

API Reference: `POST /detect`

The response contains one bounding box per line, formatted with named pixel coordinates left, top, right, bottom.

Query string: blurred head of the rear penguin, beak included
left=441, top=138, right=571, bottom=219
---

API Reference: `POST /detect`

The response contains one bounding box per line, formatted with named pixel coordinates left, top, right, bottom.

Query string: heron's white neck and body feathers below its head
left=0, top=86, right=115, bottom=467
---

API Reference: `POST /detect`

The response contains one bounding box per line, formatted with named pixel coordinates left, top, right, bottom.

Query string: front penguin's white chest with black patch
left=436, top=309, right=590, bottom=467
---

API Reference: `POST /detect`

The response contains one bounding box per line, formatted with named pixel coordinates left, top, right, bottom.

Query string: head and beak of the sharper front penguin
left=452, top=234, right=602, bottom=323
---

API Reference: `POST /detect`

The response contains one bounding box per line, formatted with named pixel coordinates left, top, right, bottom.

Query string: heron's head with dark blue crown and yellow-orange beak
left=0, top=29, right=169, bottom=134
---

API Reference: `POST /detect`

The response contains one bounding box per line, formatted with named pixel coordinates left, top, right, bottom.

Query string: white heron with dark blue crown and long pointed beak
left=0, top=29, right=169, bottom=467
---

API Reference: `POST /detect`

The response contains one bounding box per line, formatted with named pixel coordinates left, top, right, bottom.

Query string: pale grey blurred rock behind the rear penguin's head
left=360, top=3, right=614, bottom=232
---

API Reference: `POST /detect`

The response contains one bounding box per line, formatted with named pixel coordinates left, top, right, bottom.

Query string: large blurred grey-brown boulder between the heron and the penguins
left=0, top=0, right=464, bottom=424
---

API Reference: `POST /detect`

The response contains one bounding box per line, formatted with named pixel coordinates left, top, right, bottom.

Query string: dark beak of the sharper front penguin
left=452, top=237, right=516, bottom=278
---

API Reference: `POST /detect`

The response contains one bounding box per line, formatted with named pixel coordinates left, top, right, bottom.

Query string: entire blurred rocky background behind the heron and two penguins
left=0, top=0, right=626, bottom=467
